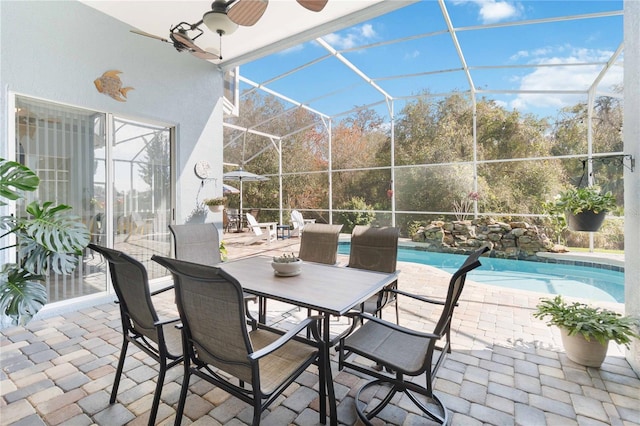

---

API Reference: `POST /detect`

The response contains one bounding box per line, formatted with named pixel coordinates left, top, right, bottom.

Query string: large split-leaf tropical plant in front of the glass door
left=0, top=158, right=89, bottom=325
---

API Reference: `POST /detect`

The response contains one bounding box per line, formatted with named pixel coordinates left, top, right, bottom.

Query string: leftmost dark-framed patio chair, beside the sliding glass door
left=88, top=244, right=183, bottom=425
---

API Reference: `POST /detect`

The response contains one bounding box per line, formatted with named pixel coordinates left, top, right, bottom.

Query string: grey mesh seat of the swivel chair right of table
left=344, top=321, right=429, bottom=375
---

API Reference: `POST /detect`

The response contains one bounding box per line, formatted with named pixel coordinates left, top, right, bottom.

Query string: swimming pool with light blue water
left=338, top=243, right=624, bottom=303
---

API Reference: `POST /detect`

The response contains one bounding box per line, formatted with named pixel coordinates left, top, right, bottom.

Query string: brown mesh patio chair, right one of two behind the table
left=348, top=225, right=400, bottom=324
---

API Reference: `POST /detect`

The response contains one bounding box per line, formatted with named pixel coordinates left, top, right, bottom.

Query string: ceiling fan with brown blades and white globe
left=131, top=0, right=328, bottom=60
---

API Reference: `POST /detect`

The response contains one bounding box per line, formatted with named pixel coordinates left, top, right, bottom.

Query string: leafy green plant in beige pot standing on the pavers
left=533, top=295, right=640, bottom=367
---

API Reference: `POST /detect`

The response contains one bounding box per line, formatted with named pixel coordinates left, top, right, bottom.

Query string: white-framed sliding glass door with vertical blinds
left=15, top=97, right=172, bottom=303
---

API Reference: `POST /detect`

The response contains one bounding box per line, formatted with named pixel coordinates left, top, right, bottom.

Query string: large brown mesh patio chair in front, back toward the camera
left=152, top=255, right=335, bottom=425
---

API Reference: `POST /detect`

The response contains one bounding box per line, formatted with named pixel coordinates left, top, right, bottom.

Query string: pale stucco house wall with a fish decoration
left=0, top=0, right=223, bottom=236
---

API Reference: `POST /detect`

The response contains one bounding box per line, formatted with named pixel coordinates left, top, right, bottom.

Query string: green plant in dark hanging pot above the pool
left=553, top=186, right=616, bottom=232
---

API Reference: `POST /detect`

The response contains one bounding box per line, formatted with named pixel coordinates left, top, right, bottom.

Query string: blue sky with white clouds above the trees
left=240, top=0, right=623, bottom=122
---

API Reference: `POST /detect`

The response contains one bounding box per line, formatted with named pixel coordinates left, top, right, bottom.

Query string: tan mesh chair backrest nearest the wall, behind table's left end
left=169, top=223, right=222, bottom=266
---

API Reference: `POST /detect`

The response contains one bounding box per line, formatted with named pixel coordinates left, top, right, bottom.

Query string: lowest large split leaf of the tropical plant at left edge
left=0, top=263, right=47, bottom=325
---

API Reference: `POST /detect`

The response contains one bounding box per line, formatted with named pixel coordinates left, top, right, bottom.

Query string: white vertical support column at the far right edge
left=623, top=0, right=640, bottom=374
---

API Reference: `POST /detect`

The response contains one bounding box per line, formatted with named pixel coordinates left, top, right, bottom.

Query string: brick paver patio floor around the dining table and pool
left=0, top=233, right=640, bottom=426
